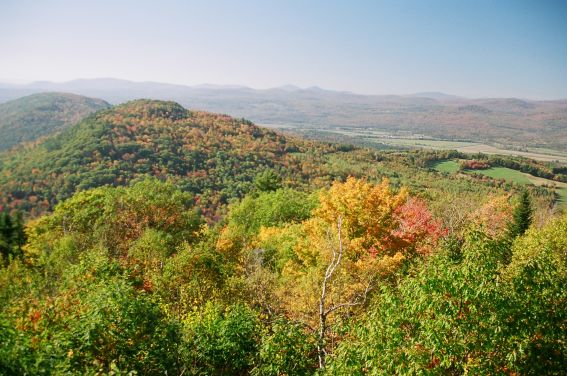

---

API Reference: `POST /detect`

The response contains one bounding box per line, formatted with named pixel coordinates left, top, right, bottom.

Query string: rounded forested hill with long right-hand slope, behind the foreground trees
left=0, top=100, right=540, bottom=220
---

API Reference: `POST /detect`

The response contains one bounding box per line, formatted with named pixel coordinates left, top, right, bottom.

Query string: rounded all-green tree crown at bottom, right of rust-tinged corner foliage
left=57, top=280, right=179, bottom=374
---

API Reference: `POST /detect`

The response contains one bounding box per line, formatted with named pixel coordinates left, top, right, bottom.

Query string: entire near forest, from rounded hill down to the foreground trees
left=0, top=100, right=567, bottom=376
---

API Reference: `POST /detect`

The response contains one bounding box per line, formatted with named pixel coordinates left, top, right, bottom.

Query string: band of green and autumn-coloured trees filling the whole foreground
left=0, top=178, right=567, bottom=376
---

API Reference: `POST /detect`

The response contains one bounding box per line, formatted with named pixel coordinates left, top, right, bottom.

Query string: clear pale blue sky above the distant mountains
left=0, top=0, right=567, bottom=99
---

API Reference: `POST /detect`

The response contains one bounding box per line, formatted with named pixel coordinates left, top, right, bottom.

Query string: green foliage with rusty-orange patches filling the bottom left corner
left=0, top=247, right=179, bottom=374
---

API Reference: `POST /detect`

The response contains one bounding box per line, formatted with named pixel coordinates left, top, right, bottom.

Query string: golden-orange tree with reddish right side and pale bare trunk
left=268, top=177, right=442, bottom=368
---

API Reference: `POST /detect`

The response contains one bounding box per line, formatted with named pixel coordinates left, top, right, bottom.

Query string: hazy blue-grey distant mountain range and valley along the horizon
left=0, top=79, right=567, bottom=151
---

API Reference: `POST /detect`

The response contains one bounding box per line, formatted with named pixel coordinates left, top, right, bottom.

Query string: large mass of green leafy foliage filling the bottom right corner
left=329, top=218, right=567, bottom=375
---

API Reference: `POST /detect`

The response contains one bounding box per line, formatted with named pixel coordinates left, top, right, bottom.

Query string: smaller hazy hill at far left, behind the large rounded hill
left=0, top=93, right=110, bottom=150
